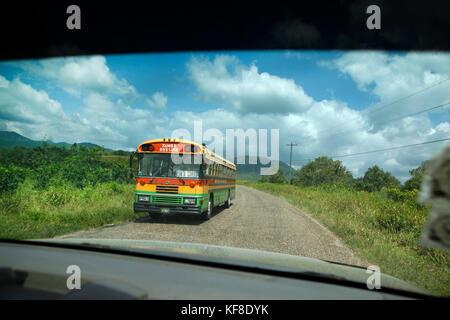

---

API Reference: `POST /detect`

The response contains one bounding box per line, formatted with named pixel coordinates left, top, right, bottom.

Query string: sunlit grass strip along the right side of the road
left=237, top=180, right=450, bottom=296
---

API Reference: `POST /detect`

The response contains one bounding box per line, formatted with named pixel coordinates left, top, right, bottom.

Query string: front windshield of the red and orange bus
left=138, top=153, right=201, bottom=178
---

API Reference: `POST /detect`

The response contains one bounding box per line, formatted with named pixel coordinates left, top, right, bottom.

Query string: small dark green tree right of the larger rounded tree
left=355, top=166, right=400, bottom=192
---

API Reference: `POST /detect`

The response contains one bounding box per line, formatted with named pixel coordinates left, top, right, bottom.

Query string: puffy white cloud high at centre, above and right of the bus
left=187, top=55, right=313, bottom=114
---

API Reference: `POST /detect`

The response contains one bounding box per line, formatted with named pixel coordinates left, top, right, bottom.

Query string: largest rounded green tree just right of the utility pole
left=292, top=157, right=353, bottom=186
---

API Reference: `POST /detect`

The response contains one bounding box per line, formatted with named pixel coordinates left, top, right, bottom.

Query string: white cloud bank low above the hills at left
left=0, top=76, right=170, bottom=149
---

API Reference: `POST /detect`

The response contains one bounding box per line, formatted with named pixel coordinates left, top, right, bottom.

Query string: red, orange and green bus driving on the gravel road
left=130, top=139, right=236, bottom=219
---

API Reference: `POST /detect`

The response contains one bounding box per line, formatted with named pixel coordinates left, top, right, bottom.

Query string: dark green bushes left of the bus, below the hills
left=0, top=144, right=133, bottom=192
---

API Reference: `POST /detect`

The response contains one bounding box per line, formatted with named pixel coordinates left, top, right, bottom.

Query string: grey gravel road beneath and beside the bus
left=60, top=186, right=366, bottom=266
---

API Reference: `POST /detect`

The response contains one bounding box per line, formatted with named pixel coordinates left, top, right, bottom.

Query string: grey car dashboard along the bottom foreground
left=0, top=242, right=424, bottom=300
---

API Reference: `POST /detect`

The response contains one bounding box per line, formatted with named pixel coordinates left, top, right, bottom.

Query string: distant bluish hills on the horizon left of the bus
left=0, top=131, right=113, bottom=152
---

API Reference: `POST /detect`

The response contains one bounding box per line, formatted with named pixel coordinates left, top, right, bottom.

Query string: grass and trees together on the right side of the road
left=238, top=158, right=450, bottom=296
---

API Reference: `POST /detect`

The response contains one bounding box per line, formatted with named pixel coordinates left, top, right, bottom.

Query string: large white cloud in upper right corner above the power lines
left=319, top=51, right=450, bottom=128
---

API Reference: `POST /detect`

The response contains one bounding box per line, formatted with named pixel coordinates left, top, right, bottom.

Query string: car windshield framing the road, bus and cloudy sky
left=0, top=50, right=450, bottom=296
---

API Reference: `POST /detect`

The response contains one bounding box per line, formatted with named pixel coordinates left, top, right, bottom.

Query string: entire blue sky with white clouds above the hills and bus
left=0, top=51, right=450, bottom=180
